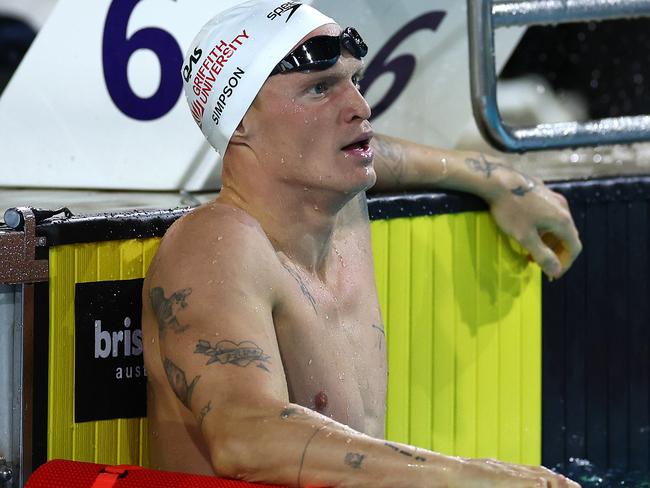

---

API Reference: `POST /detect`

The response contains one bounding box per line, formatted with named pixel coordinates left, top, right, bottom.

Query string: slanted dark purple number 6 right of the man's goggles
left=361, top=11, right=446, bottom=119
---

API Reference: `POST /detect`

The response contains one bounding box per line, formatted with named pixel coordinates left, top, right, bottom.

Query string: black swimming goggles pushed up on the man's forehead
left=270, top=27, right=368, bottom=76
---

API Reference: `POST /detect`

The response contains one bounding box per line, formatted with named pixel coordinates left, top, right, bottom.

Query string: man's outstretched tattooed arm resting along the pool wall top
left=372, top=135, right=582, bottom=278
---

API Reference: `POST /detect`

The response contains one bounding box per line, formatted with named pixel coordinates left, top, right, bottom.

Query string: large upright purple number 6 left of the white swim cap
left=102, top=0, right=183, bottom=120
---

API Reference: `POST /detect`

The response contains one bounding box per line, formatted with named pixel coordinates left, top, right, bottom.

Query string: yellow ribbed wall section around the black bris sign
left=47, top=239, right=160, bottom=465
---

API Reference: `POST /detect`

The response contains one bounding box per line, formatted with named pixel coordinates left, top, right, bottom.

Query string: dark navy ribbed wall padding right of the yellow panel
left=542, top=177, right=650, bottom=471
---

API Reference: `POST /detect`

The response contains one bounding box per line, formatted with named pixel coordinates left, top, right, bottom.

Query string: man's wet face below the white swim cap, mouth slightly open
left=246, top=24, right=376, bottom=193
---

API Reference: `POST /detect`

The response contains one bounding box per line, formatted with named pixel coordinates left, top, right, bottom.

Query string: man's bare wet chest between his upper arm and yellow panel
left=274, top=248, right=386, bottom=435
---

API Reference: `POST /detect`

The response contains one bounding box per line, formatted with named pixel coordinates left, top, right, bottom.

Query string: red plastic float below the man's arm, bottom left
left=25, top=459, right=282, bottom=488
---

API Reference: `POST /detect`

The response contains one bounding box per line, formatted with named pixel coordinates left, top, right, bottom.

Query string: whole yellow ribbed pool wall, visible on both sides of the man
left=47, top=212, right=541, bottom=466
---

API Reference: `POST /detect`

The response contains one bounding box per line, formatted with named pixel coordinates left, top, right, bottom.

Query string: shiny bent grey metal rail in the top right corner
left=467, top=0, right=650, bottom=152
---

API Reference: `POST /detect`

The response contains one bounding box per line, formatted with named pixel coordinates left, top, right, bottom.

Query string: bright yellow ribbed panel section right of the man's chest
left=372, top=213, right=541, bottom=464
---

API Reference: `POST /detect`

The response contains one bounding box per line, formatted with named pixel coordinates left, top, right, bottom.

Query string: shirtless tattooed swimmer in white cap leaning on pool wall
left=143, top=0, right=580, bottom=488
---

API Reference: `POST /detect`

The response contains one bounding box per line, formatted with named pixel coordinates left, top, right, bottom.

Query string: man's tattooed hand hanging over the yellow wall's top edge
left=465, top=154, right=582, bottom=279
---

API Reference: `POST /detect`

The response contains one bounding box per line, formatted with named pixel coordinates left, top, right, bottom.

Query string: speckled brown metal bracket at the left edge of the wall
left=0, top=207, right=49, bottom=284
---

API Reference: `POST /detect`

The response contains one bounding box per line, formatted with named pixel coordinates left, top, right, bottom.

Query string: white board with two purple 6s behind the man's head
left=0, top=0, right=521, bottom=191
